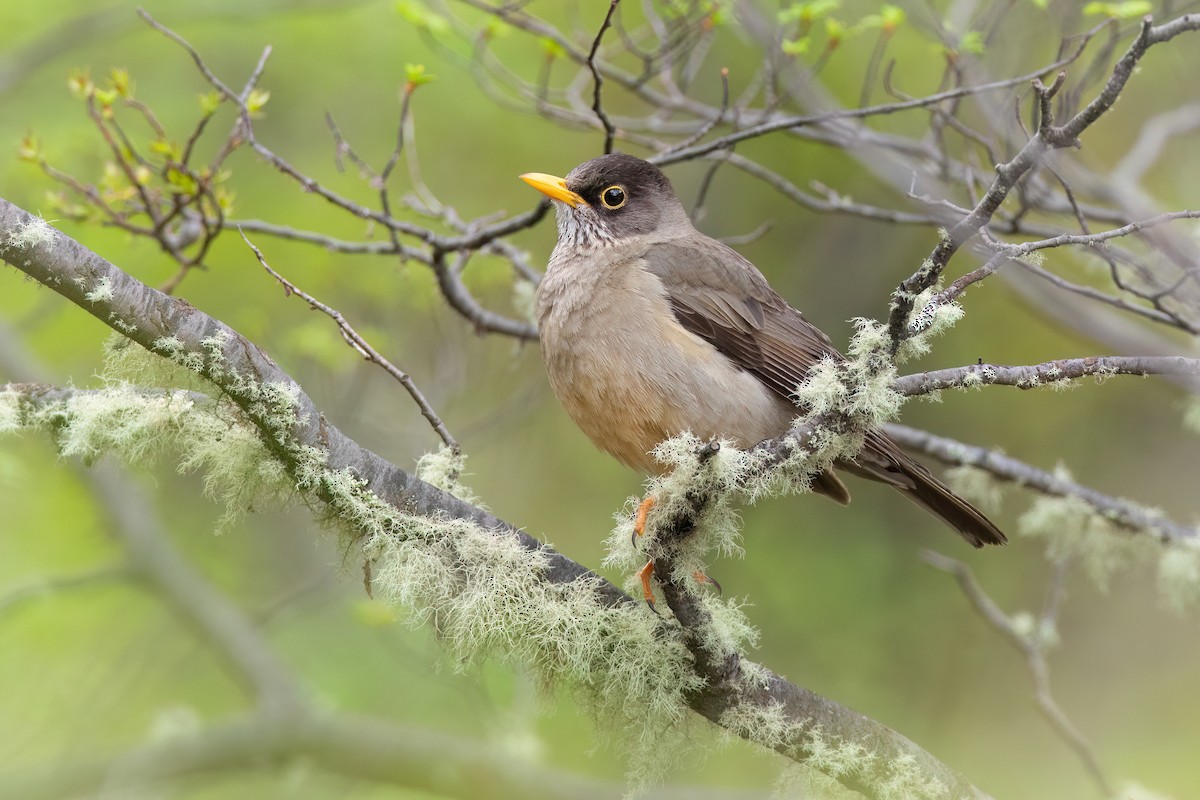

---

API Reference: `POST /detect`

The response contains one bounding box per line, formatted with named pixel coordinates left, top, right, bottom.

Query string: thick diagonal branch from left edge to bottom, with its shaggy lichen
left=0, top=195, right=982, bottom=798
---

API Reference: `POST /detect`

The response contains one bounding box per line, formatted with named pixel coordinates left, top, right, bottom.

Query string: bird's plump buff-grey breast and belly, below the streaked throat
left=538, top=253, right=796, bottom=473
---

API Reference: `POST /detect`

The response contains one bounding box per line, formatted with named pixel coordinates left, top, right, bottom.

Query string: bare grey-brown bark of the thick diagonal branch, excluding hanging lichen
left=0, top=199, right=983, bottom=798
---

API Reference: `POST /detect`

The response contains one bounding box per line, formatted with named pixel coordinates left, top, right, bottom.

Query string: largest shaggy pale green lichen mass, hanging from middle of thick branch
left=364, top=510, right=702, bottom=784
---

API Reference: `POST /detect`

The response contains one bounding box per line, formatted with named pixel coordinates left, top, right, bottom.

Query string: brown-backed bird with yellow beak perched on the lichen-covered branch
left=521, top=152, right=1007, bottom=600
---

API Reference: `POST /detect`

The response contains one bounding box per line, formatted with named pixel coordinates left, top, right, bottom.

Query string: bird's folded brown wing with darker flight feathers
left=642, top=237, right=841, bottom=401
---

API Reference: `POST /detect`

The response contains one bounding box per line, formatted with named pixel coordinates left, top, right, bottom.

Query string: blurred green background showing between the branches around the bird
left=0, top=0, right=1200, bottom=798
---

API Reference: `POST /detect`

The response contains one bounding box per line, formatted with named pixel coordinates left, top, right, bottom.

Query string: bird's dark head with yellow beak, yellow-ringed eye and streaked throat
left=521, top=152, right=691, bottom=247
